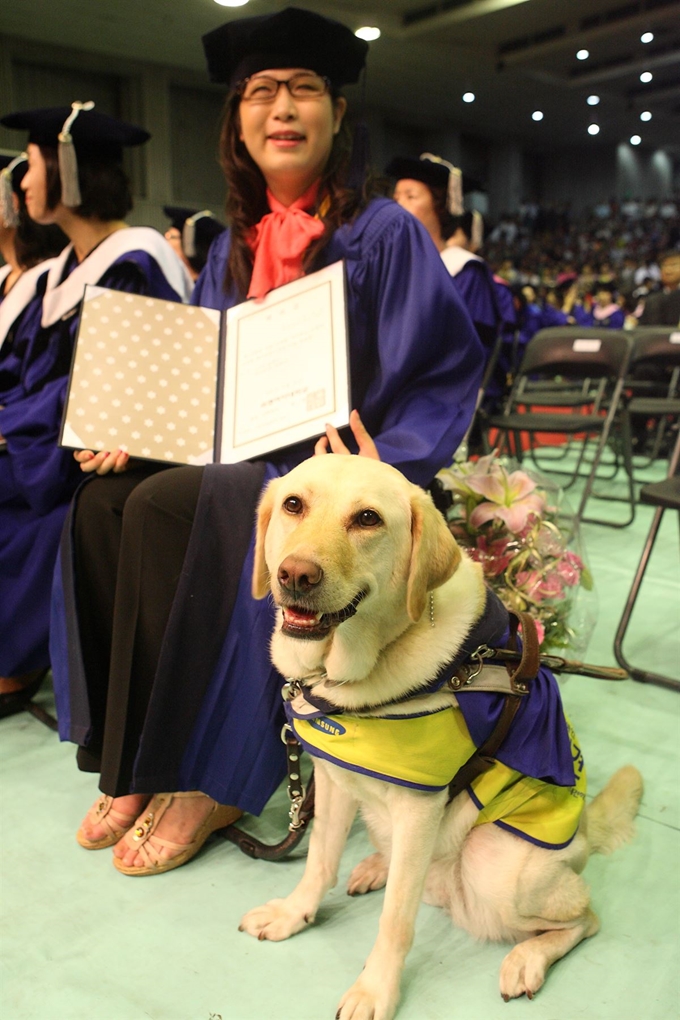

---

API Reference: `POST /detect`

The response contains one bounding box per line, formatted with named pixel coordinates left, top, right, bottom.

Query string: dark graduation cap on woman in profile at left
left=0, top=106, right=151, bottom=162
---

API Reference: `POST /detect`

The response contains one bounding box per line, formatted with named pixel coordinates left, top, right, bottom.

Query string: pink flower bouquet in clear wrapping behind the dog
left=437, top=452, right=596, bottom=655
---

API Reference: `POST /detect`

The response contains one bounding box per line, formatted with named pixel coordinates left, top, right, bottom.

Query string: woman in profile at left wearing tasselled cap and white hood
left=0, top=104, right=191, bottom=710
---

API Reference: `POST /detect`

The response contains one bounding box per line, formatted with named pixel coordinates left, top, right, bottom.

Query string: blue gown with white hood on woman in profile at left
left=0, top=227, right=190, bottom=676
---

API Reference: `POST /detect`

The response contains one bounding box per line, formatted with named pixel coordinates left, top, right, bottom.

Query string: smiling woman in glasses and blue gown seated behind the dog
left=52, top=8, right=482, bottom=875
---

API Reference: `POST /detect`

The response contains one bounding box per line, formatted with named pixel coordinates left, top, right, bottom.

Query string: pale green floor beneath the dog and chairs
left=0, top=465, right=680, bottom=1020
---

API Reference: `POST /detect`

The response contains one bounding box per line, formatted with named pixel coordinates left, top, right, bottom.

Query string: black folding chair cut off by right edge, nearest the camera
left=614, top=431, right=680, bottom=691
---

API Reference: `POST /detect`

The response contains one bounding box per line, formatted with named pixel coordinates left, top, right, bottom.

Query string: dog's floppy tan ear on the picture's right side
left=406, top=492, right=461, bottom=620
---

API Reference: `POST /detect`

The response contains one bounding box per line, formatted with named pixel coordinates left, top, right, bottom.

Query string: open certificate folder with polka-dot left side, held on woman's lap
left=60, top=262, right=350, bottom=464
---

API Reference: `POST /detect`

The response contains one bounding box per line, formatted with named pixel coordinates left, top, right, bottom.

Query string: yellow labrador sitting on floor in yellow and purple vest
left=241, top=455, right=642, bottom=1020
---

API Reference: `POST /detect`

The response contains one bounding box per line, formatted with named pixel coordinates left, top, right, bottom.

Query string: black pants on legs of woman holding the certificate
left=74, top=465, right=203, bottom=797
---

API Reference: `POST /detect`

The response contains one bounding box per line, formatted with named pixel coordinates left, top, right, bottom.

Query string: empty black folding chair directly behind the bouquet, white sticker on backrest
left=484, top=326, right=635, bottom=527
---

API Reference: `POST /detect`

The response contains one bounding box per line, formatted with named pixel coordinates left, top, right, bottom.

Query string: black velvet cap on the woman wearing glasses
left=203, top=7, right=368, bottom=89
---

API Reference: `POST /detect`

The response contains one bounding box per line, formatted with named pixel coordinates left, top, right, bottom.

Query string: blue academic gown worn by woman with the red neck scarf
left=55, top=199, right=483, bottom=814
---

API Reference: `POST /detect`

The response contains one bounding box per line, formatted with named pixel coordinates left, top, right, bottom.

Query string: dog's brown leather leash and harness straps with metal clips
left=219, top=610, right=628, bottom=861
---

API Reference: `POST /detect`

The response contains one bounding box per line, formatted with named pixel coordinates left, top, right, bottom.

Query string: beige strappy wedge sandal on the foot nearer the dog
left=113, top=791, right=243, bottom=875
